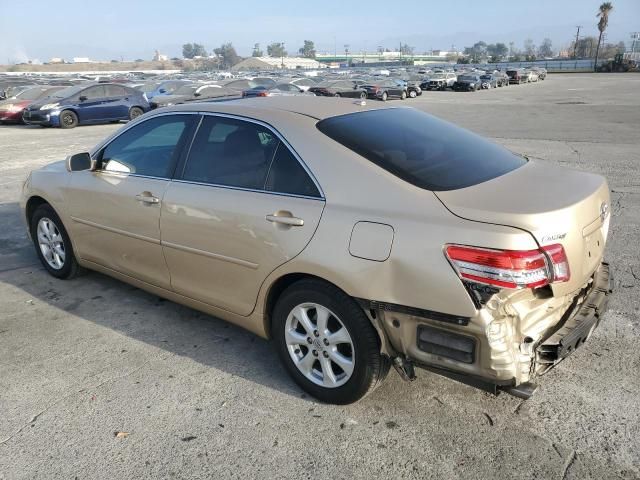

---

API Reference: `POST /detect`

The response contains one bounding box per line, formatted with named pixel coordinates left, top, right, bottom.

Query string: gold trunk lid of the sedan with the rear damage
left=435, top=161, right=610, bottom=296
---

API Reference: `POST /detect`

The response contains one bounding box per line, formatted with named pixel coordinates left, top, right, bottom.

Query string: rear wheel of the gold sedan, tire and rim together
left=272, top=280, right=390, bottom=405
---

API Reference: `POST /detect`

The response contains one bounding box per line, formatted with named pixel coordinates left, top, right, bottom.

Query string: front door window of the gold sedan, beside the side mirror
left=101, top=115, right=193, bottom=178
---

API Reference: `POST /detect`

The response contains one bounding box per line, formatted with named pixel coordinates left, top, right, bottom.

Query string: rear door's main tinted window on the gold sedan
left=183, top=116, right=278, bottom=190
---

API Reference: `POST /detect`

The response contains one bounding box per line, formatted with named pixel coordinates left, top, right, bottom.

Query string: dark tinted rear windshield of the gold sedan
left=317, top=108, right=526, bottom=191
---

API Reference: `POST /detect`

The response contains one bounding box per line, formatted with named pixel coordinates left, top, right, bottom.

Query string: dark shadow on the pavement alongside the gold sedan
left=0, top=203, right=306, bottom=398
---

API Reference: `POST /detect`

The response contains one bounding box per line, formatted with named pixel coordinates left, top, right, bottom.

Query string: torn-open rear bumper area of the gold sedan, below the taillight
left=360, top=263, right=613, bottom=398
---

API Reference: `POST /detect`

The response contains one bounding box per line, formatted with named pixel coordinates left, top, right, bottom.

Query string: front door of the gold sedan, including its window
left=65, top=114, right=199, bottom=289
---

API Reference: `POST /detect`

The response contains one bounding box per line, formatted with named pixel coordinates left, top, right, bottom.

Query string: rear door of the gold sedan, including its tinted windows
left=160, top=115, right=324, bottom=315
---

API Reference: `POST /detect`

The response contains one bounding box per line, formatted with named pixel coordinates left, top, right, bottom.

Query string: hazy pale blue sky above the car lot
left=0, top=0, right=640, bottom=63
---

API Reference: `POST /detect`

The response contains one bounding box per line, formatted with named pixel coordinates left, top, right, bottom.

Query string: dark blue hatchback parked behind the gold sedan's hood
left=22, top=83, right=149, bottom=128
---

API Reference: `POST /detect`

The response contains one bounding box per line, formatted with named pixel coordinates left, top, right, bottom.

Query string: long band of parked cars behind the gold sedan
left=0, top=67, right=547, bottom=128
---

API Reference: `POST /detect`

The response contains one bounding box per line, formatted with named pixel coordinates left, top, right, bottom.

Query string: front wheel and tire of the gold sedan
left=30, top=204, right=80, bottom=280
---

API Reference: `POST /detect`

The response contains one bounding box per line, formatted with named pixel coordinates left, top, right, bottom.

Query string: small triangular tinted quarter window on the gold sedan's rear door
left=265, top=142, right=320, bottom=197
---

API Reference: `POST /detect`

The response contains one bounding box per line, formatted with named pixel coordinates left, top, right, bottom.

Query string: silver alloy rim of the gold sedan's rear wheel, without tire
left=284, top=303, right=355, bottom=388
